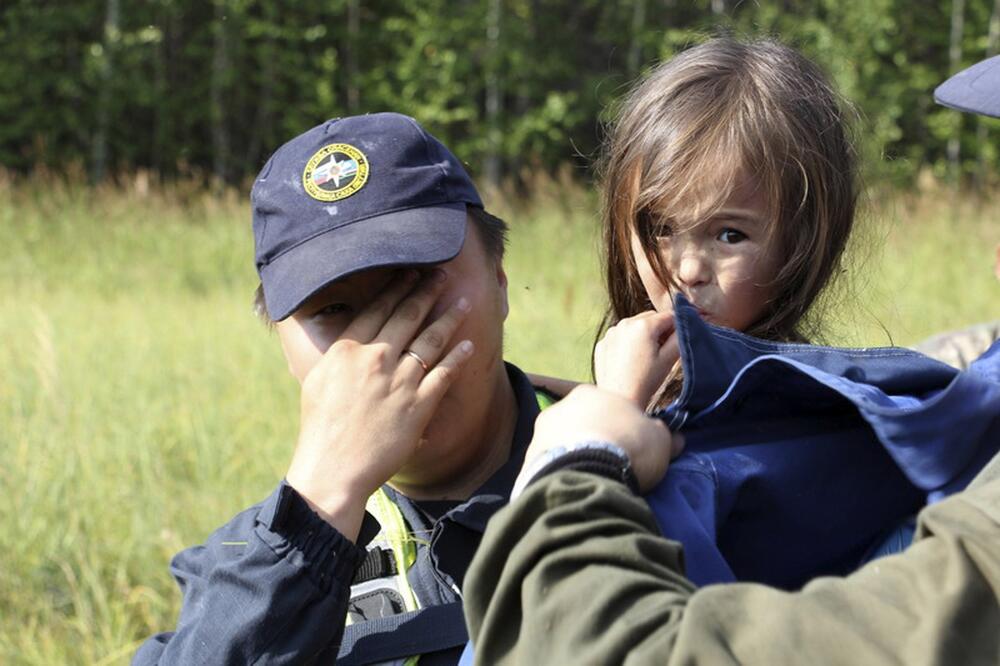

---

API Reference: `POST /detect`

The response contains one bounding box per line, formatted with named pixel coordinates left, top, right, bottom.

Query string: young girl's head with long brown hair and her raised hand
left=594, top=38, right=858, bottom=407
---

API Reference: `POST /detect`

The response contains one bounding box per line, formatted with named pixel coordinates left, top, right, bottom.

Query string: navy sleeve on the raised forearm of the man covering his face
left=133, top=486, right=364, bottom=665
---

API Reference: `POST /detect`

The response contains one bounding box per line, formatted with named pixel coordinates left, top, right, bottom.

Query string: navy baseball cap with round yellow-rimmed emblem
left=250, top=113, right=483, bottom=321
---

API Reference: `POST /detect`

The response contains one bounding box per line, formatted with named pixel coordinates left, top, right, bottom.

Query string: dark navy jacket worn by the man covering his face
left=132, top=364, right=539, bottom=666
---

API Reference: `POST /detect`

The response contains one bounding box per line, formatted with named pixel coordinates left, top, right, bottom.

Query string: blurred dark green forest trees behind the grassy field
left=0, top=0, right=998, bottom=185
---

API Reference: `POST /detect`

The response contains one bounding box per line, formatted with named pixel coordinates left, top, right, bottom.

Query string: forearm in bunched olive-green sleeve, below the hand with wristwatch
left=465, top=472, right=694, bottom=664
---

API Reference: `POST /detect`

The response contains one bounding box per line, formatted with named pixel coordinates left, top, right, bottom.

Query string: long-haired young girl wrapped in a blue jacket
left=519, top=39, right=997, bottom=589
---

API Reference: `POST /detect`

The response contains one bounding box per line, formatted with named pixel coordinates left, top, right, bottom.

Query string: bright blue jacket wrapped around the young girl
left=647, top=297, right=1000, bottom=589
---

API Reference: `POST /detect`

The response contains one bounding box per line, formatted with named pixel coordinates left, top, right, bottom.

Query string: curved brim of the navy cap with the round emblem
left=260, top=203, right=466, bottom=321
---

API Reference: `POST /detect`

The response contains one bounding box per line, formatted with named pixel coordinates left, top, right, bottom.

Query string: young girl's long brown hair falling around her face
left=597, top=38, right=858, bottom=404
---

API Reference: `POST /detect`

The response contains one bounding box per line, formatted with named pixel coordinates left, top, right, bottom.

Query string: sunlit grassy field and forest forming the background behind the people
left=0, top=0, right=1000, bottom=665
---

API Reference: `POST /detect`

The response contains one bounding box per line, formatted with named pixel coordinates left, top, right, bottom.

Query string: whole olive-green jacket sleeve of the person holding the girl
left=465, top=472, right=1000, bottom=666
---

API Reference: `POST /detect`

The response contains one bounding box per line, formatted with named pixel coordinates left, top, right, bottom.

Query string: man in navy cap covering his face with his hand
left=133, top=113, right=556, bottom=665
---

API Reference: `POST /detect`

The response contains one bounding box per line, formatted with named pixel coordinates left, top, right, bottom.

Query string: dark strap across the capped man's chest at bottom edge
left=337, top=601, right=469, bottom=666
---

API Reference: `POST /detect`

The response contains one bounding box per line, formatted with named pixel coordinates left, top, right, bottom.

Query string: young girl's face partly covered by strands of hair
left=632, top=177, right=780, bottom=331
